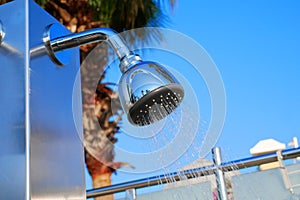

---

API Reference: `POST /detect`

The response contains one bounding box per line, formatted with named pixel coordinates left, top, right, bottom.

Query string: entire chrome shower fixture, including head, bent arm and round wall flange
left=42, top=24, right=184, bottom=126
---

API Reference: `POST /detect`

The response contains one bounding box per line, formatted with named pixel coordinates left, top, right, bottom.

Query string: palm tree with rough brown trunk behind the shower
left=31, top=0, right=175, bottom=200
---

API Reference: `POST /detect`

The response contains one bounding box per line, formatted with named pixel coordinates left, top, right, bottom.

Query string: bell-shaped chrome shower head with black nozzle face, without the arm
left=119, top=61, right=184, bottom=126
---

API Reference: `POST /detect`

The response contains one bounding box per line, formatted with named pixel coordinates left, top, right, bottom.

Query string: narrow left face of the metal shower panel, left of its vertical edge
left=0, top=1, right=26, bottom=200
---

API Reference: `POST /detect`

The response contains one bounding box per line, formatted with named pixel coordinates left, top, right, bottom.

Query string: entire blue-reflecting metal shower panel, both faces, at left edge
left=0, top=0, right=86, bottom=200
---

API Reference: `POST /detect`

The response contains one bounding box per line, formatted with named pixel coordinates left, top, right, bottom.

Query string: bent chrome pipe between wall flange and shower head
left=45, top=28, right=142, bottom=73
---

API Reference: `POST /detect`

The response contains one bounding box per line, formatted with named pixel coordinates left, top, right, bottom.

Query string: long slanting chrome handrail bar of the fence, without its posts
left=86, top=147, right=300, bottom=198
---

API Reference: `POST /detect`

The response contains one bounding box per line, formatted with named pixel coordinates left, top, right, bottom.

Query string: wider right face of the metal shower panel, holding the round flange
left=29, top=2, right=85, bottom=199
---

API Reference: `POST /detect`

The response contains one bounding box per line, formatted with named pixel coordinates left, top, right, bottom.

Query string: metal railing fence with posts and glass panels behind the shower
left=87, top=147, right=300, bottom=200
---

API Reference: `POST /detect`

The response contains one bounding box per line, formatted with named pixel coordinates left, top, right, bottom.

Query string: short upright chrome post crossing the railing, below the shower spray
left=212, top=147, right=228, bottom=200
